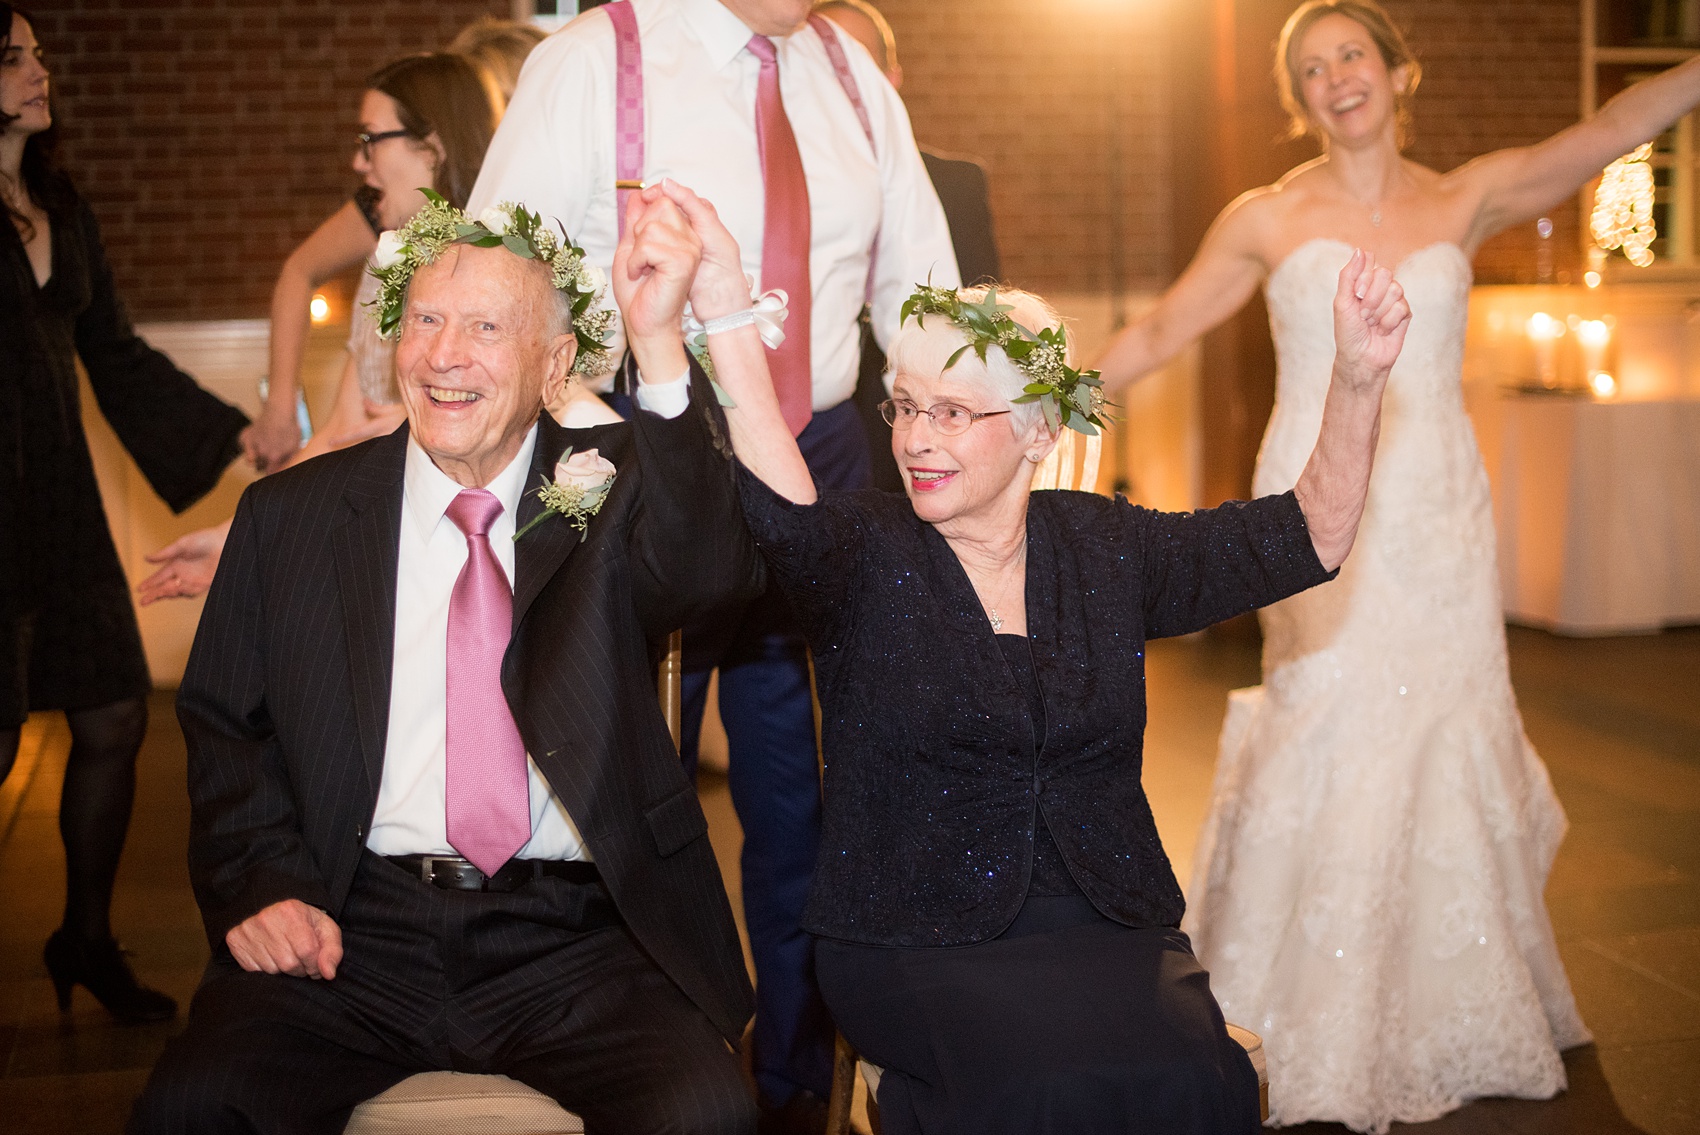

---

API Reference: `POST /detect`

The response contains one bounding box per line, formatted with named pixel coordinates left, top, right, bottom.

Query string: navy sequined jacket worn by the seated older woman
left=741, top=471, right=1331, bottom=946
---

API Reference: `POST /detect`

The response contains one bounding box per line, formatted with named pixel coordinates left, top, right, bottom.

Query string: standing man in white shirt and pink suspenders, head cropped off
left=469, top=0, right=957, bottom=1132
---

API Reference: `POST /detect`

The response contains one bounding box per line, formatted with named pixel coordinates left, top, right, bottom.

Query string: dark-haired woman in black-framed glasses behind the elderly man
left=139, top=53, right=510, bottom=605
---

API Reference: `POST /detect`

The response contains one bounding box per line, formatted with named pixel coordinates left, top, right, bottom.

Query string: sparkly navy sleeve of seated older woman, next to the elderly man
left=738, top=462, right=867, bottom=651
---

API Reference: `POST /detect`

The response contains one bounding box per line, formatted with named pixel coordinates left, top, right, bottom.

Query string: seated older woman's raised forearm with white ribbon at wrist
left=642, top=180, right=816, bottom=505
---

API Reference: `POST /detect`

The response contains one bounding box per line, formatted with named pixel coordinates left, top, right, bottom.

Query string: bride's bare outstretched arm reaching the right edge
left=1448, top=59, right=1700, bottom=253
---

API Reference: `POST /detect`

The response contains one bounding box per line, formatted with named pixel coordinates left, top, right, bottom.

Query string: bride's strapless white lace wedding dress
left=1187, top=240, right=1588, bottom=1132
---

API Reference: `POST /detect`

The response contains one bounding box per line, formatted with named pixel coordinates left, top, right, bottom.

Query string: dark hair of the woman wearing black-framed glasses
left=366, top=51, right=496, bottom=209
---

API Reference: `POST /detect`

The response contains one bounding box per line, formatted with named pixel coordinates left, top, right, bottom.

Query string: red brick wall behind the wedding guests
left=32, top=0, right=1579, bottom=319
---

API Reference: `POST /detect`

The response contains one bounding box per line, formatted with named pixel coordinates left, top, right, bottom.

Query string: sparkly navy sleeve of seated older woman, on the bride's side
left=1125, top=493, right=1338, bottom=639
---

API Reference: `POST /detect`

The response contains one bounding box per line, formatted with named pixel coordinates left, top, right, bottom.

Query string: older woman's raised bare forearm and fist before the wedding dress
left=1294, top=250, right=1411, bottom=571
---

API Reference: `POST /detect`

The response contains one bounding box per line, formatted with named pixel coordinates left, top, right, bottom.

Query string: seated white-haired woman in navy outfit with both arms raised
left=615, top=184, right=1409, bottom=1135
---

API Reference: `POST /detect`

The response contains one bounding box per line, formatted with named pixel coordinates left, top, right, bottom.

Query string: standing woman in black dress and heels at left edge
left=0, top=3, right=248, bottom=1021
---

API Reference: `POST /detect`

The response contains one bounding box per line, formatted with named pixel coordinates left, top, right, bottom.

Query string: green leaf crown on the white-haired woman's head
left=899, top=284, right=1110, bottom=437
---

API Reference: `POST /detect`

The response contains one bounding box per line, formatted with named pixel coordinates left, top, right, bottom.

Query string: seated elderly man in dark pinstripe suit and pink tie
left=131, top=195, right=763, bottom=1135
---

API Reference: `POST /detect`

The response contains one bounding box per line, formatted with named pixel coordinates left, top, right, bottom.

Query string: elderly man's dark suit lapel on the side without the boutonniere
left=332, top=426, right=408, bottom=799
